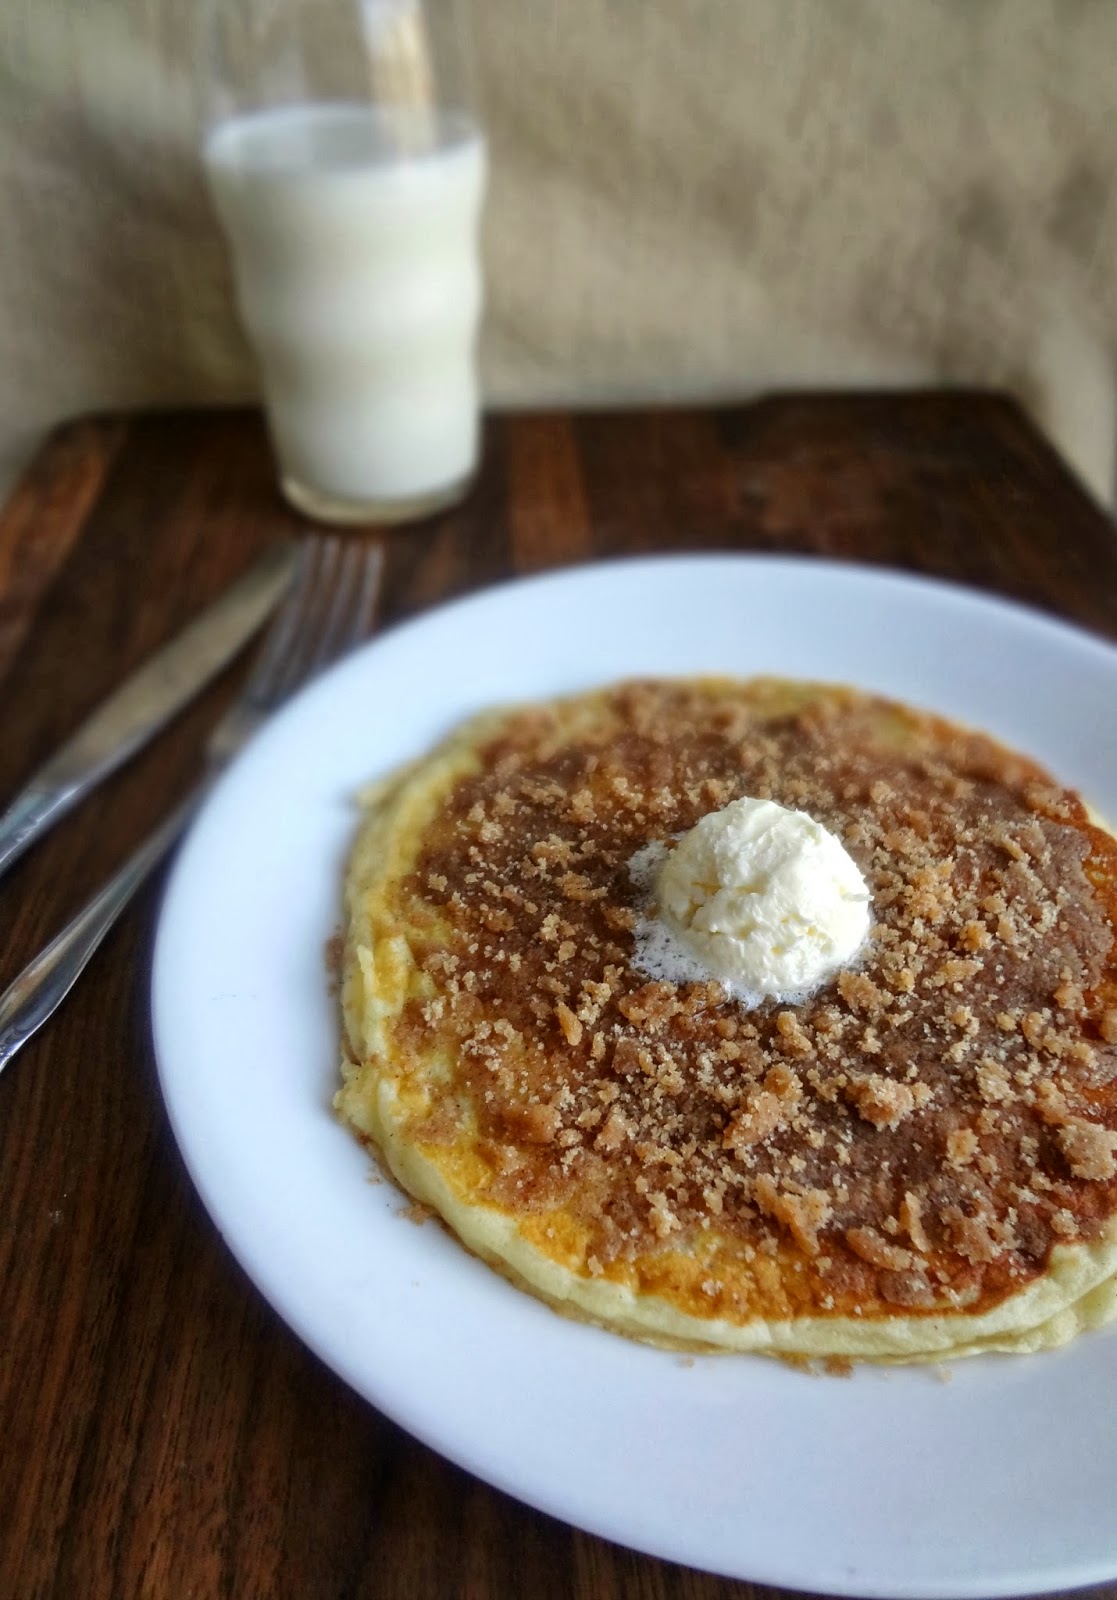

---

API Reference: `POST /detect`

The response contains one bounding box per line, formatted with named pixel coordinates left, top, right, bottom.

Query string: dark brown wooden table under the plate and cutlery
left=0, top=394, right=1117, bottom=1600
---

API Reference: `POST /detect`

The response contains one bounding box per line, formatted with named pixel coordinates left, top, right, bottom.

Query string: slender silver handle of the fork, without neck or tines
left=0, top=787, right=203, bottom=1072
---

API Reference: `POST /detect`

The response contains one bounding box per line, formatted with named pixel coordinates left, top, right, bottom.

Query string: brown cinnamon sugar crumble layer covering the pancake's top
left=388, top=683, right=1117, bottom=1315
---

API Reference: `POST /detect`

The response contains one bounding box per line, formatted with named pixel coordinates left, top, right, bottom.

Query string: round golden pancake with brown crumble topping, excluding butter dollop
left=336, top=678, right=1117, bottom=1360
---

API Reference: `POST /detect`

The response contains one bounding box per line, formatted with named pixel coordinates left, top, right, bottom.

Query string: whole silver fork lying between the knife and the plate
left=0, top=536, right=384, bottom=1072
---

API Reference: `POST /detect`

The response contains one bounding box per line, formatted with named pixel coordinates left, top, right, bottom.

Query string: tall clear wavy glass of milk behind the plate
left=203, top=0, right=486, bottom=523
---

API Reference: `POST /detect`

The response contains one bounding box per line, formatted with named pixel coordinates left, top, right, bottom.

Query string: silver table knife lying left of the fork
left=0, top=542, right=294, bottom=874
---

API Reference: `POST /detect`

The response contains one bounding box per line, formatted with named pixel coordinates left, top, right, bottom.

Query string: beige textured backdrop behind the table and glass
left=0, top=0, right=1117, bottom=498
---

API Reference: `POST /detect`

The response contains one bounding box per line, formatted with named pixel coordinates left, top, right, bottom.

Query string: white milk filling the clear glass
left=205, top=104, right=485, bottom=517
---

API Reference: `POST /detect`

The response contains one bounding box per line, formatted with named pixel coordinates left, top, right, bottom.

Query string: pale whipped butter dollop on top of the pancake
left=632, top=798, right=871, bottom=1005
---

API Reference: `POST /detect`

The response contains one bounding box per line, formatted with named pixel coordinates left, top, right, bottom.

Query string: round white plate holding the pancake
left=152, top=557, right=1117, bottom=1597
